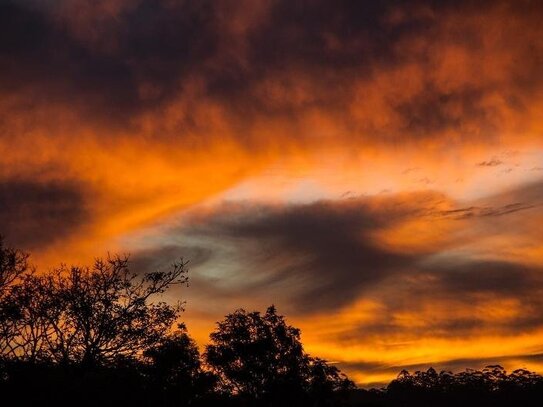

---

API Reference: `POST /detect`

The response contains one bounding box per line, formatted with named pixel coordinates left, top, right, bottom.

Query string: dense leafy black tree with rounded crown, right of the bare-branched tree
left=204, top=306, right=352, bottom=405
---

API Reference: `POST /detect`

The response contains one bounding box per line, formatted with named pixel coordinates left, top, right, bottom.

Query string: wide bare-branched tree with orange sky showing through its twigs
left=47, top=257, right=187, bottom=367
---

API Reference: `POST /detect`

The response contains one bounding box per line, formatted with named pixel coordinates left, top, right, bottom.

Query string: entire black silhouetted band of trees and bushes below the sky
left=0, top=239, right=543, bottom=407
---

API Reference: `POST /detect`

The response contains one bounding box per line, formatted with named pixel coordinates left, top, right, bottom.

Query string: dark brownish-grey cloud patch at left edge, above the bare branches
left=0, top=180, right=89, bottom=250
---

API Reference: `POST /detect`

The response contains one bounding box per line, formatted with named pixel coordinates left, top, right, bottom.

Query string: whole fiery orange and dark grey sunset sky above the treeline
left=0, top=0, right=543, bottom=386
